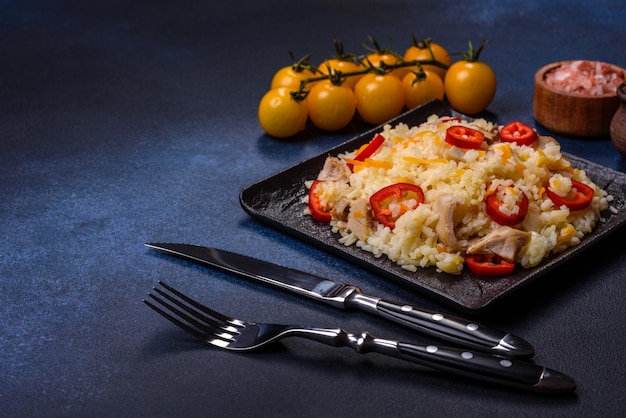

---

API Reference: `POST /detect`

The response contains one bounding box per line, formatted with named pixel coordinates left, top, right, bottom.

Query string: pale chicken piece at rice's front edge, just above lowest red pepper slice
left=467, top=226, right=530, bottom=261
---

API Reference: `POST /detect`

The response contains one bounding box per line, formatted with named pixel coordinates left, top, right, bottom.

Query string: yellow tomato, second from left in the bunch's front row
left=306, top=80, right=356, bottom=131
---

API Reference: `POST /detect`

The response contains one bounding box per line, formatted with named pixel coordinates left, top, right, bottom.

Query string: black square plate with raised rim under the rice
left=240, top=101, right=626, bottom=311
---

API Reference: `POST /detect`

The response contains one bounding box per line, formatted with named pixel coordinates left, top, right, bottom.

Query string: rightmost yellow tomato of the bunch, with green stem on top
left=443, top=41, right=496, bottom=115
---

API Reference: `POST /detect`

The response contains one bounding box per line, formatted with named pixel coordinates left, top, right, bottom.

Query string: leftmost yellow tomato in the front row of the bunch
left=258, top=87, right=308, bottom=138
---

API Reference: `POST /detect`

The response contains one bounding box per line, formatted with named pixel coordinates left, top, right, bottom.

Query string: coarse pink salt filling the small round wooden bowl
left=544, top=60, right=624, bottom=96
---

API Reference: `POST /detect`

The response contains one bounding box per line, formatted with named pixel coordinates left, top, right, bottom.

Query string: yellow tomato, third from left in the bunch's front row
left=354, top=73, right=404, bottom=125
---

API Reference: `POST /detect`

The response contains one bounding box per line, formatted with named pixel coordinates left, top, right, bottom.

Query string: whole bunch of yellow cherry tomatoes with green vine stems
left=258, top=37, right=496, bottom=138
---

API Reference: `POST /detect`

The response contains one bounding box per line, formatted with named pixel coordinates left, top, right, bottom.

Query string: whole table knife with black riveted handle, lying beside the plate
left=145, top=243, right=535, bottom=358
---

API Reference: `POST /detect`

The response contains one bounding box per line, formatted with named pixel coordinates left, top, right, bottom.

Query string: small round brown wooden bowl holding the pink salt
left=533, top=61, right=626, bottom=138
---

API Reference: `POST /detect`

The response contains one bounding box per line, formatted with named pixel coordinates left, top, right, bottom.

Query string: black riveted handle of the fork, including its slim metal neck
left=294, top=328, right=576, bottom=394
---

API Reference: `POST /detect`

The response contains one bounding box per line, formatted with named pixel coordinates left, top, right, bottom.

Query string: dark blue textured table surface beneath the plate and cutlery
left=0, top=0, right=626, bottom=417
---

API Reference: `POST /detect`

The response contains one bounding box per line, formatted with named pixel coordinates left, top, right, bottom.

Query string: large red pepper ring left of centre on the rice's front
left=370, top=183, right=424, bottom=229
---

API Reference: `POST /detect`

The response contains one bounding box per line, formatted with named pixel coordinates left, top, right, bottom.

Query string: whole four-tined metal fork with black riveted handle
left=143, top=281, right=576, bottom=394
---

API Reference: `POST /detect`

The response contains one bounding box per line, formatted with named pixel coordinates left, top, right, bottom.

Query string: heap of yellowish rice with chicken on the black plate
left=304, top=115, right=611, bottom=274
